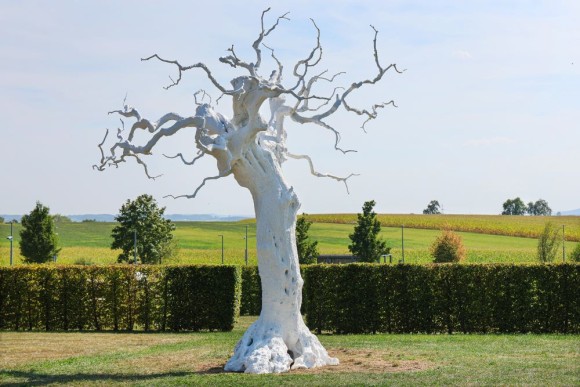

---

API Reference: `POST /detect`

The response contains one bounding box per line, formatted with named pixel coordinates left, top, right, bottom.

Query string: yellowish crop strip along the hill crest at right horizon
left=308, top=214, right=580, bottom=242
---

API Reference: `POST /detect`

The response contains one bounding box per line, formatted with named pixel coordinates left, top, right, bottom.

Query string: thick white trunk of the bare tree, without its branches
left=225, top=143, right=338, bottom=373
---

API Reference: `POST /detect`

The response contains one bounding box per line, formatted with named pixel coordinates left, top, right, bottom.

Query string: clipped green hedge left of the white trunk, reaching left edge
left=0, top=265, right=242, bottom=331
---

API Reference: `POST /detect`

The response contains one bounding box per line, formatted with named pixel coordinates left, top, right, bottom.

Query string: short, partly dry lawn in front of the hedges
left=0, top=317, right=580, bottom=386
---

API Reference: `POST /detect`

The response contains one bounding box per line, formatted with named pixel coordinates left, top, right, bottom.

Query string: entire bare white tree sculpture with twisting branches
left=94, top=9, right=400, bottom=373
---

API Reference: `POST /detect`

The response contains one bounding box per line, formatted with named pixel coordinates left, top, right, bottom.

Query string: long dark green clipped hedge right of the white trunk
left=304, top=264, right=580, bottom=333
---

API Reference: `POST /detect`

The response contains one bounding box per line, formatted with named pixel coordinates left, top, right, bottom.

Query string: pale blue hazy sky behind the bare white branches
left=0, top=0, right=580, bottom=214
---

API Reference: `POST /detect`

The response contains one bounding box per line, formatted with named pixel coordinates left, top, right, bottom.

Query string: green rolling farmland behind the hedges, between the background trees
left=0, top=214, right=580, bottom=265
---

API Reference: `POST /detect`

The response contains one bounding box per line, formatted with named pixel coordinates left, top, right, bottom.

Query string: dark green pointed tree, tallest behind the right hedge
left=348, top=200, right=391, bottom=262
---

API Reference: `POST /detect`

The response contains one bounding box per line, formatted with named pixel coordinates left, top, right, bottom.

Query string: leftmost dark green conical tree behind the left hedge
left=20, top=202, right=61, bottom=263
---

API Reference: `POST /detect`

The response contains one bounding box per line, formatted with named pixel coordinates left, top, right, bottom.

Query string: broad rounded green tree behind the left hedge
left=111, top=195, right=175, bottom=264
